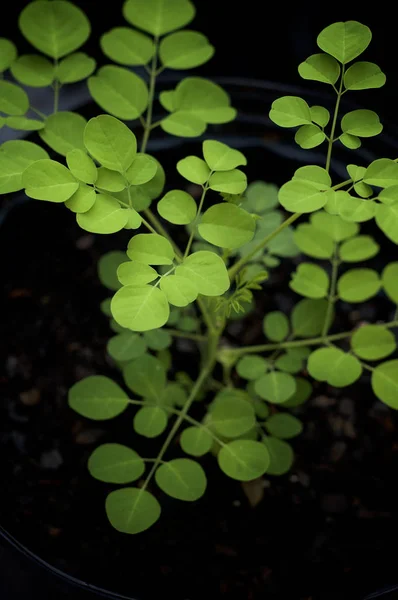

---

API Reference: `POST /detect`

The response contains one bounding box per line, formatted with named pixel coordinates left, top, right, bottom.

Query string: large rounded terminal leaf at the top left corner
left=19, top=0, right=91, bottom=59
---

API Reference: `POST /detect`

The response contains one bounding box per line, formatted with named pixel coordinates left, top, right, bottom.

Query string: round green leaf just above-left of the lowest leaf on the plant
left=87, top=444, right=145, bottom=483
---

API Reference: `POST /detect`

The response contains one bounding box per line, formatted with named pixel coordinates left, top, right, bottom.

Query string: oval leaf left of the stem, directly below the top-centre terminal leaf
left=100, top=27, right=155, bottom=67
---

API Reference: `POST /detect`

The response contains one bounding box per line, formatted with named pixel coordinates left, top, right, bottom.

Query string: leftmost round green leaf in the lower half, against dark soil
left=68, top=375, right=129, bottom=421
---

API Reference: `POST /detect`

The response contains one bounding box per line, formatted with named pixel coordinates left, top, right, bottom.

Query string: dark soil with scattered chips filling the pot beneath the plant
left=0, top=136, right=398, bottom=600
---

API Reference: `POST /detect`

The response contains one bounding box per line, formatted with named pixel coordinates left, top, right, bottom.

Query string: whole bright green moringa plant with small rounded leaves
left=0, top=0, right=398, bottom=534
